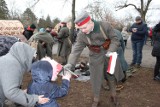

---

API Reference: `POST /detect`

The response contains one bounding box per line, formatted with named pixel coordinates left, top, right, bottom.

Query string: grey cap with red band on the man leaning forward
left=74, top=11, right=91, bottom=26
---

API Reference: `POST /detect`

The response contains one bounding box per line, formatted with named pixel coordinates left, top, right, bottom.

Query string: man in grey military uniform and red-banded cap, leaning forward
left=64, top=12, right=124, bottom=107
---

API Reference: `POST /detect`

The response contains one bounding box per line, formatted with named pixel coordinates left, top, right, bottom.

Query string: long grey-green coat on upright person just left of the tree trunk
left=57, top=27, right=72, bottom=56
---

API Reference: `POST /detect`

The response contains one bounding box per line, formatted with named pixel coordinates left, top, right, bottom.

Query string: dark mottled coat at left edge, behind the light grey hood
left=0, top=36, right=19, bottom=56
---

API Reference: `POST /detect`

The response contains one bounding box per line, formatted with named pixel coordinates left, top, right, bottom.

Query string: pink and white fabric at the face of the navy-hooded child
left=42, top=57, right=63, bottom=81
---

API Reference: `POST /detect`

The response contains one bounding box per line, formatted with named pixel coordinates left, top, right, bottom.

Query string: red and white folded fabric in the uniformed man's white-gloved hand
left=106, top=52, right=118, bottom=75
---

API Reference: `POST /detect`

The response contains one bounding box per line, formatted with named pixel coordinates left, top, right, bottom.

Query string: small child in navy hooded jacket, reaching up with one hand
left=27, top=60, right=71, bottom=107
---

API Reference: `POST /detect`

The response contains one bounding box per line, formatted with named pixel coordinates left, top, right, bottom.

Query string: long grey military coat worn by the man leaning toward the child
left=68, top=21, right=123, bottom=95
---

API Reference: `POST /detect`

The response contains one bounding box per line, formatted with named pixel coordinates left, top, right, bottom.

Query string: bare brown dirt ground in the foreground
left=23, top=68, right=160, bottom=107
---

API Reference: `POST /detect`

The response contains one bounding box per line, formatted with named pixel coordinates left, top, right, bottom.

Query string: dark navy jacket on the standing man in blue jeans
left=129, top=22, right=148, bottom=41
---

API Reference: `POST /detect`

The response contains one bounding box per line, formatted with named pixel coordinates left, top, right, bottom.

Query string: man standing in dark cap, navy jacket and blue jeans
left=129, top=16, right=147, bottom=68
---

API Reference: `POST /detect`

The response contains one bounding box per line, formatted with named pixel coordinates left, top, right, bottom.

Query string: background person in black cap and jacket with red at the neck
left=23, top=24, right=36, bottom=40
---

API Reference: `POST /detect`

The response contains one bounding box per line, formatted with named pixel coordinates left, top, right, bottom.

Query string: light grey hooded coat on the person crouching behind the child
left=0, top=42, right=38, bottom=107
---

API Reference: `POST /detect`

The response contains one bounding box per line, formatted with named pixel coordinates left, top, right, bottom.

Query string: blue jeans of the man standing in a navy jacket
left=132, top=40, right=144, bottom=64
